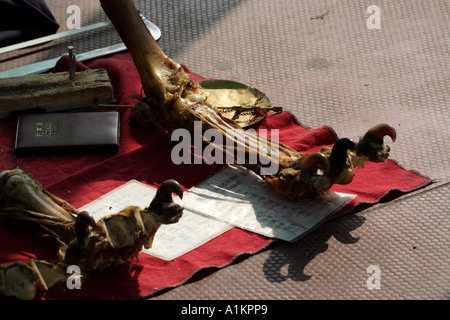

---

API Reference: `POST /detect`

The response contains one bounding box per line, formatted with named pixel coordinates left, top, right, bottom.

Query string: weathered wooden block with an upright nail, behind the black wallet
left=0, top=69, right=113, bottom=118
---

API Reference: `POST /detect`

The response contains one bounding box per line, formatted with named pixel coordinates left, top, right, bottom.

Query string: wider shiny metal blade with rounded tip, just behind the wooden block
left=0, top=14, right=161, bottom=79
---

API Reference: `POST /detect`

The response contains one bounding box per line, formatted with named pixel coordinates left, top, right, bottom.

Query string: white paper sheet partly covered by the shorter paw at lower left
left=79, top=180, right=232, bottom=260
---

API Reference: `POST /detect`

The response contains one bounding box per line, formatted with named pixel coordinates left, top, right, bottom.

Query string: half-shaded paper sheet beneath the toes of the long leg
left=184, top=166, right=356, bottom=241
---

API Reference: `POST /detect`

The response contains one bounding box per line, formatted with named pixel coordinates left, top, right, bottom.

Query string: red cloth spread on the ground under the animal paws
left=0, top=53, right=431, bottom=299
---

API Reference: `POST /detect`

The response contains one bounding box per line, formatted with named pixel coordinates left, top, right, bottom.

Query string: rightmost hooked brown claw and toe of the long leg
left=357, top=123, right=397, bottom=162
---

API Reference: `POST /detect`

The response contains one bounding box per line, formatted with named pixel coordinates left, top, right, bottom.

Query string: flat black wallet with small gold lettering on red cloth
left=15, top=111, right=120, bottom=154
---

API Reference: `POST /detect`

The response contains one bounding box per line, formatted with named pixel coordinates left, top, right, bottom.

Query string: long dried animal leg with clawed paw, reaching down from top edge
left=100, top=0, right=395, bottom=200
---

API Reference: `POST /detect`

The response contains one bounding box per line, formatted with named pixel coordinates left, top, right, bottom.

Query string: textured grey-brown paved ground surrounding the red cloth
left=0, top=0, right=450, bottom=299
